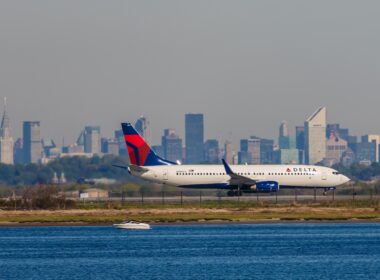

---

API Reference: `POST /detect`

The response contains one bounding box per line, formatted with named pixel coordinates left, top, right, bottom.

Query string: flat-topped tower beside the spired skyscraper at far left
left=23, top=121, right=42, bottom=163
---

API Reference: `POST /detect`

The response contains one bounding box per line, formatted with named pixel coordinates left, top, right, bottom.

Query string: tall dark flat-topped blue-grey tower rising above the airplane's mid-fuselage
left=185, top=114, right=204, bottom=164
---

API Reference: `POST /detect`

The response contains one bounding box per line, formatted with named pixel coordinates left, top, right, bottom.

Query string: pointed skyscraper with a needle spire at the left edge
left=0, top=99, right=14, bottom=164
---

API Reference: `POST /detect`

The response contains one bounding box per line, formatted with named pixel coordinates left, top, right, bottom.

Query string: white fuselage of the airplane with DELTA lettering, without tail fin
left=131, top=165, right=349, bottom=189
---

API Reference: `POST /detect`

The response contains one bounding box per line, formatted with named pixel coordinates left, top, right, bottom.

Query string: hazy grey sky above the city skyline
left=0, top=0, right=380, bottom=147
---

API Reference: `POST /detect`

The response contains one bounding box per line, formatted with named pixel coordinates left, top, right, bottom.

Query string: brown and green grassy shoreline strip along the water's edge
left=0, top=206, right=380, bottom=227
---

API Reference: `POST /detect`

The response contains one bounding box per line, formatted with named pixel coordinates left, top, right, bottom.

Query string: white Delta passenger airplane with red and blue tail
left=118, top=123, right=350, bottom=196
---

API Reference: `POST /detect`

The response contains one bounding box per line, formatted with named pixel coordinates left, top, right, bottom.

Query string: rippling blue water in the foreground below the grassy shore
left=0, top=224, right=380, bottom=280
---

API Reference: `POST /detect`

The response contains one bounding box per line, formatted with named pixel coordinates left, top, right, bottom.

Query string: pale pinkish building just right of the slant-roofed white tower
left=323, top=131, right=348, bottom=166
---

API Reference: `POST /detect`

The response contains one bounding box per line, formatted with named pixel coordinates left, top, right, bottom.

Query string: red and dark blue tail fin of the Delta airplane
left=121, top=123, right=176, bottom=166
